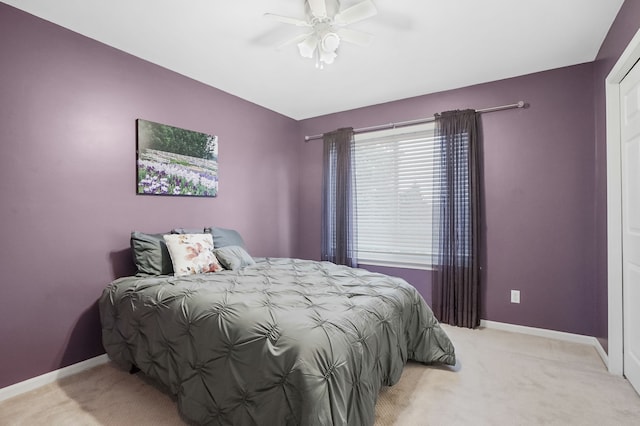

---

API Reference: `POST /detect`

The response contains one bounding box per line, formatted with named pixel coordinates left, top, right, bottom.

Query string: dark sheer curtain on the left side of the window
left=321, top=127, right=357, bottom=267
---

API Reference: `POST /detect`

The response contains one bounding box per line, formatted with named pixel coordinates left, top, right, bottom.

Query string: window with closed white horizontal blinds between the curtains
left=354, top=123, right=452, bottom=268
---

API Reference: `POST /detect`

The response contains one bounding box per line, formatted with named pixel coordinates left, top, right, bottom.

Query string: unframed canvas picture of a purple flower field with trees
left=136, top=119, right=218, bottom=197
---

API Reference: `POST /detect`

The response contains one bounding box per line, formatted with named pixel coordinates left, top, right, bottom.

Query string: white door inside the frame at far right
left=620, top=57, right=640, bottom=393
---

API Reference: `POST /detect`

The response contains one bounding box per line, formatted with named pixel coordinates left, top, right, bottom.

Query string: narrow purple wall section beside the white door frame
left=593, top=0, right=640, bottom=347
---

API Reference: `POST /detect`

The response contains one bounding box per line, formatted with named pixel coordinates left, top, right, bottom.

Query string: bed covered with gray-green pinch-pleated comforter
left=99, top=230, right=455, bottom=425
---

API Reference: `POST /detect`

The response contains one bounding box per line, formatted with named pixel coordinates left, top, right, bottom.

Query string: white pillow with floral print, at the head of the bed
left=163, top=234, right=222, bottom=277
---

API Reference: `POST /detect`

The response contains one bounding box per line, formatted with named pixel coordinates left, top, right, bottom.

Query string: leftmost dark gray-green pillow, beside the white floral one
left=130, top=231, right=173, bottom=275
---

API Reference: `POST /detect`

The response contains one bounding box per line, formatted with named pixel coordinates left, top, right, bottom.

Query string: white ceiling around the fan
left=2, top=0, right=624, bottom=120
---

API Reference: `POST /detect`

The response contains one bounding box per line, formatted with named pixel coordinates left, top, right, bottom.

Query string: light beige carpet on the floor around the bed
left=0, top=326, right=640, bottom=426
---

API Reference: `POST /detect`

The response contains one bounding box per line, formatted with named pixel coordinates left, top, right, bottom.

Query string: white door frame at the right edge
left=605, top=30, right=640, bottom=375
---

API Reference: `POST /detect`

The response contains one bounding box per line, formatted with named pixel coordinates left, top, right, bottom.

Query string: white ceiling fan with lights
left=265, top=0, right=378, bottom=69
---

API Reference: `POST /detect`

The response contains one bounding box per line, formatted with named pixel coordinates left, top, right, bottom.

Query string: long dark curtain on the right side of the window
left=432, top=110, right=480, bottom=328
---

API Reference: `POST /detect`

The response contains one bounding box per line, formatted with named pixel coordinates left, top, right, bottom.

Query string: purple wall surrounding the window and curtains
left=298, top=64, right=597, bottom=335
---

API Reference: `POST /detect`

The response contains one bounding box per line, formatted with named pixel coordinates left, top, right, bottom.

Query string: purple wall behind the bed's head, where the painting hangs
left=0, top=4, right=299, bottom=388
